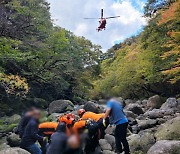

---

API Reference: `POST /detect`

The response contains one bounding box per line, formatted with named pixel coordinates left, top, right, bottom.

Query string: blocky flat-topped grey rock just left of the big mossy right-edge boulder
left=137, top=119, right=157, bottom=130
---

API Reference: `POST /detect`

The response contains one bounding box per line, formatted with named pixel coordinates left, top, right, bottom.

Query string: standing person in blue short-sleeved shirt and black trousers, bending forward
left=103, top=99, right=130, bottom=154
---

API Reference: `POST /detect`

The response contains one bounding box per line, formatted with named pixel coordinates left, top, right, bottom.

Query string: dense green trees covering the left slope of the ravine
left=0, top=0, right=101, bottom=113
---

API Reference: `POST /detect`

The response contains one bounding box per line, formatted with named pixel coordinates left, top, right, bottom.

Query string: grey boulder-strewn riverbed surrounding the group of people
left=0, top=95, right=180, bottom=154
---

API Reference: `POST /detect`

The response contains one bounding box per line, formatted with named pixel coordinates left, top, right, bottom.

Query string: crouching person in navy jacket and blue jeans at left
left=21, top=109, right=45, bottom=154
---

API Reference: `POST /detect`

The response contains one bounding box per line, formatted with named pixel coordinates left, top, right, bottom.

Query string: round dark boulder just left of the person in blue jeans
left=7, top=133, right=21, bottom=147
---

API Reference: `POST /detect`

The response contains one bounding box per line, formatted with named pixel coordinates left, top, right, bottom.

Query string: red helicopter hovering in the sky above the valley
left=84, top=9, right=120, bottom=32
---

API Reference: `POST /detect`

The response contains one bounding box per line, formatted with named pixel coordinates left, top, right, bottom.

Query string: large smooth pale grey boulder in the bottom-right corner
left=147, top=140, right=180, bottom=154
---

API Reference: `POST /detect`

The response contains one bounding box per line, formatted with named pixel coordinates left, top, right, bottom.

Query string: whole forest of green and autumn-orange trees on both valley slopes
left=0, top=0, right=180, bottom=114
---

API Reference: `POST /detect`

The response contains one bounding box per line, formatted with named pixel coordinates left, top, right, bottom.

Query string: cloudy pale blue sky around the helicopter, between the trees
left=47, top=0, right=147, bottom=52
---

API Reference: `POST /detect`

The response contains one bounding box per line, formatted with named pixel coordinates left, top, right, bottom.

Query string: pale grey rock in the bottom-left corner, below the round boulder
left=0, top=147, right=30, bottom=154
